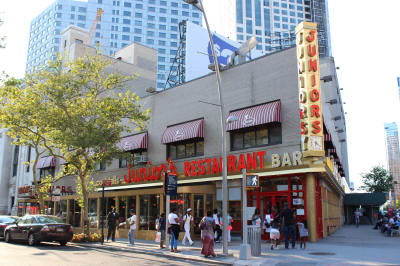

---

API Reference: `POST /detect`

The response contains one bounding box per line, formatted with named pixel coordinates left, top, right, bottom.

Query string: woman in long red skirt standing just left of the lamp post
left=199, top=211, right=216, bottom=258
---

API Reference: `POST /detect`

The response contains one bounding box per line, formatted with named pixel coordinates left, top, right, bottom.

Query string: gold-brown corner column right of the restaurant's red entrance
left=306, top=173, right=318, bottom=242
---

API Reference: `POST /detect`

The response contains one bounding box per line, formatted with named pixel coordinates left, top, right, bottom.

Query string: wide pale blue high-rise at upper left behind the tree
left=26, top=0, right=202, bottom=88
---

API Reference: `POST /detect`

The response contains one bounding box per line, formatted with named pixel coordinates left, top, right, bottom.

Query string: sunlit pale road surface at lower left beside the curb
left=0, top=240, right=212, bottom=266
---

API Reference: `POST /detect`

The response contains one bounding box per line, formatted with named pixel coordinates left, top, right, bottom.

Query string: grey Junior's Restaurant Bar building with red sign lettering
left=16, top=24, right=348, bottom=241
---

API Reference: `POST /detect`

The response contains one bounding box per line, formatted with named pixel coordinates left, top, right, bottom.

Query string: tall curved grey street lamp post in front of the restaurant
left=183, top=0, right=228, bottom=255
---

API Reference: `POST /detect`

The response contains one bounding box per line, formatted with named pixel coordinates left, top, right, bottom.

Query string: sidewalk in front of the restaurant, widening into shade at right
left=68, top=226, right=400, bottom=266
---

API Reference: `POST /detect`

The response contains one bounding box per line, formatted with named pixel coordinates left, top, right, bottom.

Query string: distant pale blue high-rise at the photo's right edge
left=385, top=122, right=400, bottom=200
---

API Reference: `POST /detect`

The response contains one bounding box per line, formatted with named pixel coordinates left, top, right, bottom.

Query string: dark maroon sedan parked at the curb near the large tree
left=4, top=215, right=73, bottom=246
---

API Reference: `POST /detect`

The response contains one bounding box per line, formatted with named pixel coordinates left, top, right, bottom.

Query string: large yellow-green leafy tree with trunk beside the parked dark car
left=0, top=52, right=149, bottom=233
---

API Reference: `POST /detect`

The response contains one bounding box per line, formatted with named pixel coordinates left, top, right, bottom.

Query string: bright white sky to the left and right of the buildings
left=0, top=0, right=400, bottom=191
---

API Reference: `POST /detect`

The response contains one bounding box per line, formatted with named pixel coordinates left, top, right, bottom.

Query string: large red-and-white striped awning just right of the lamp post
left=226, top=101, right=281, bottom=131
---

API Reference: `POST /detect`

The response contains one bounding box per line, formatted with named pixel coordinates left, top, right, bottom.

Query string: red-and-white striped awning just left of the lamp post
left=161, top=118, right=204, bottom=144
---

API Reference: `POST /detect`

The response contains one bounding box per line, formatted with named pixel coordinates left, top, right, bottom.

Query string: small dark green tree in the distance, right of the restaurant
left=361, top=166, right=393, bottom=192
